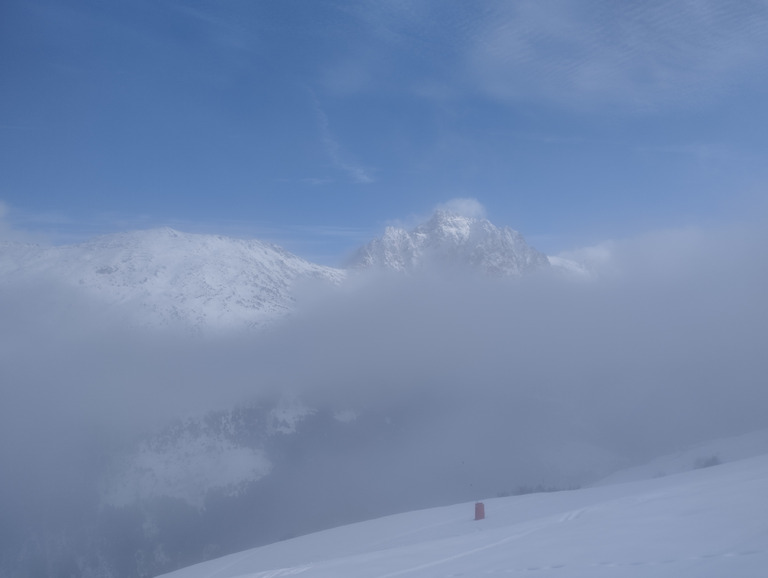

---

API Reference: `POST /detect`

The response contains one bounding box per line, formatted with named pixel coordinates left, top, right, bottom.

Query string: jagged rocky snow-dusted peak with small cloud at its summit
left=350, top=210, right=549, bottom=276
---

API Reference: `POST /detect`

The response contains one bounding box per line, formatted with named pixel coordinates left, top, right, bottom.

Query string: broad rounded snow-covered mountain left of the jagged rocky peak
left=0, top=228, right=345, bottom=329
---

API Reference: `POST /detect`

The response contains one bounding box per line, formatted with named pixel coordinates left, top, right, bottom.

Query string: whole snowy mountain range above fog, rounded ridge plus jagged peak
left=0, top=210, right=550, bottom=330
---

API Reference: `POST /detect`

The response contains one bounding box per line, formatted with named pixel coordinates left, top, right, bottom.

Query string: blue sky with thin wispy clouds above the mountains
left=0, top=0, right=768, bottom=264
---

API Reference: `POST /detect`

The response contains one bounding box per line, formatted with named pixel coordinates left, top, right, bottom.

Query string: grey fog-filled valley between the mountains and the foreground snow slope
left=0, top=223, right=768, bottom=577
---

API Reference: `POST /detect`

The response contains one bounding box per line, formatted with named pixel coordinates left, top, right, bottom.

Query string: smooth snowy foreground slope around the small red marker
left=159, top=454, right=768, bottom=578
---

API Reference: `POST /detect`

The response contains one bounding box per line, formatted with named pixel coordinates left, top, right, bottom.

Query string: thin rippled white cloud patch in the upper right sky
left=465, top=0, right=768, bottom=109
